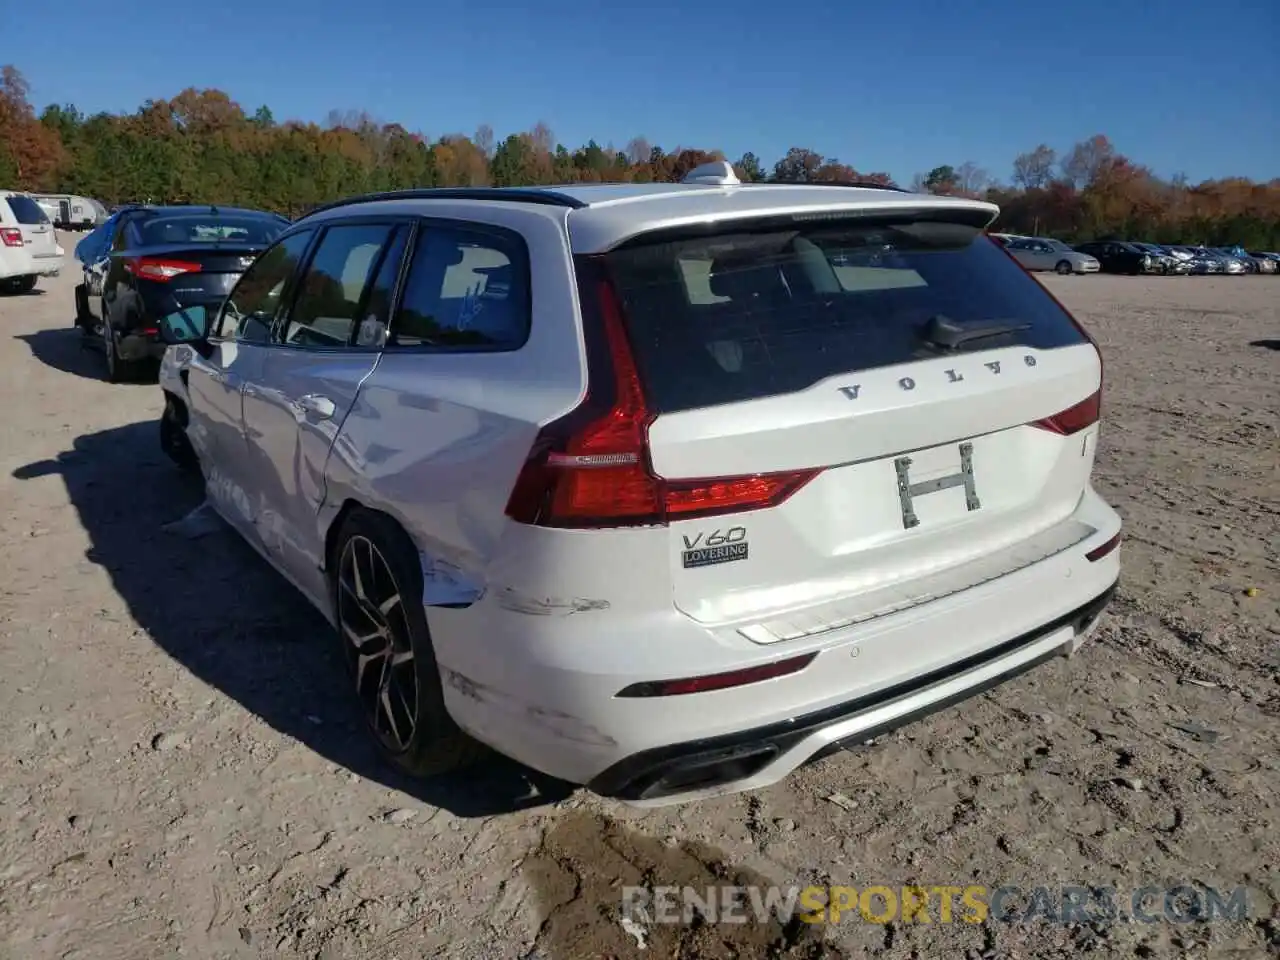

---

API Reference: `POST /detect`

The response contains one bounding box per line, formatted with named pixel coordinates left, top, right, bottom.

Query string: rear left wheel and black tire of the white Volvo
left=329, top=508, right=489, bottom=777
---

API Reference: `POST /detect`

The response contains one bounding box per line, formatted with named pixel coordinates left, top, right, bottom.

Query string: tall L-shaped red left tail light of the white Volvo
left=507, top=257, right=819, bottom=527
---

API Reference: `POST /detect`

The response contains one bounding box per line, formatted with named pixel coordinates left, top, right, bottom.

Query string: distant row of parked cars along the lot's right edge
left=991, top=233, right=1280, bottom=276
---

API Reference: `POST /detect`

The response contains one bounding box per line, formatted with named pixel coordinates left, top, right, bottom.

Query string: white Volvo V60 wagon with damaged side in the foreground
left=161, top=165, right=1120, bottom=805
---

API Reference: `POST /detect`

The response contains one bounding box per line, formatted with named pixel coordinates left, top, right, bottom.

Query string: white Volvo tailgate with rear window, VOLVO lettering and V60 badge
left=608, top=216, right=1102, bottom=630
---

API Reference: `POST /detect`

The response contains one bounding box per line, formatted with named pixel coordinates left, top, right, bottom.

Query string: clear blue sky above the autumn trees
left=0, top=0, right=1280, bottom=182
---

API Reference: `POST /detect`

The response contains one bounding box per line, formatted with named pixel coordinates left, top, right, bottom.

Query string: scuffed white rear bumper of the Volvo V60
left=428, top=489, right=1120, bottom=805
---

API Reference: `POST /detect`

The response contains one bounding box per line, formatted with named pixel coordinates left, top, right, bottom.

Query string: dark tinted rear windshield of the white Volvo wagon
left=608, top=219, right=1084, bottom=412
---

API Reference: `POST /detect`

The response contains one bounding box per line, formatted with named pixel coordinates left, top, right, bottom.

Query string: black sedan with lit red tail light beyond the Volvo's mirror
left=76, top=205, right=289, bottom=383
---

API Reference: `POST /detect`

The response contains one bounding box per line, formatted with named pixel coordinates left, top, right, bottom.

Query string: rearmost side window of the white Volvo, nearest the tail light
left=388, top=224, right=531, bottom=349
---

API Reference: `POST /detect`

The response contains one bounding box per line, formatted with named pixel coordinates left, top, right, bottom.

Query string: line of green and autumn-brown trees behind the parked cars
left=0, top=67, right=1280, bottom=250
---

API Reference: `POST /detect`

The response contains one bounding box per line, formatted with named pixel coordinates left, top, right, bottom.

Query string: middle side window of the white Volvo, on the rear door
left=278, top=224, right=397, bottom=347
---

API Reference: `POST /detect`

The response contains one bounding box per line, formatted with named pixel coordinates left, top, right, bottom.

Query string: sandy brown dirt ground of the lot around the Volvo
left=0, top=238, right=1280, bottom=960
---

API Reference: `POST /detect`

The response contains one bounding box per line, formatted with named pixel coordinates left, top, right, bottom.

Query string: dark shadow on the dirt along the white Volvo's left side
left=13, top=419, right=573, bottom=817
